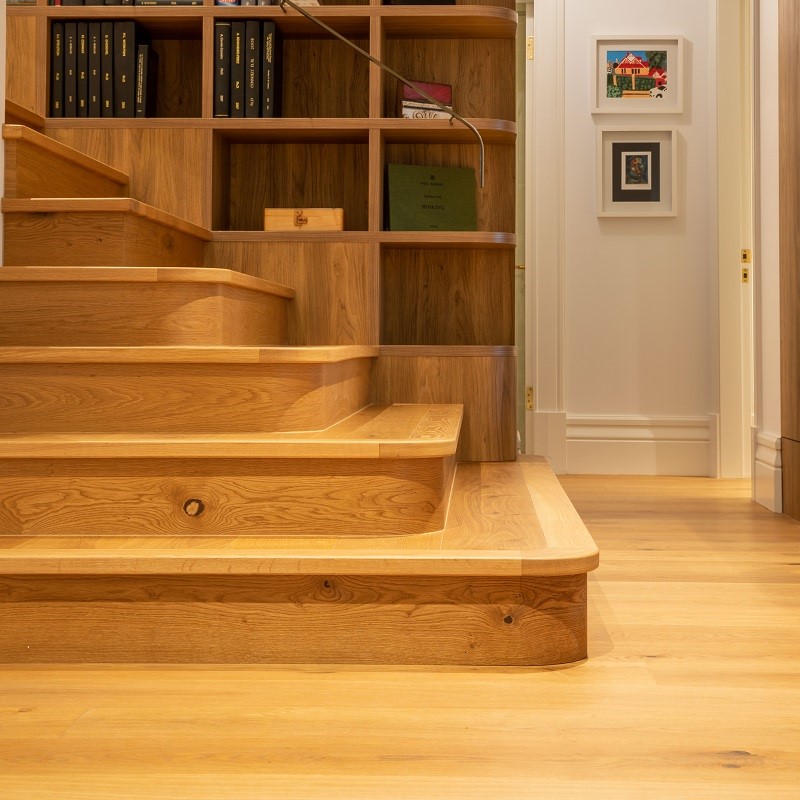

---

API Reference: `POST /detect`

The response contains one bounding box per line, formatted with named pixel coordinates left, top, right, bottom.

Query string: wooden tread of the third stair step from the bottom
left=0, top=345, right=378, bottom=364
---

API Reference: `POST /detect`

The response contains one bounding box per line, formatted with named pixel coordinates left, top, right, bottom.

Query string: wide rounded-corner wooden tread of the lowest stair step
left=0, top=457, right=599, bottom=577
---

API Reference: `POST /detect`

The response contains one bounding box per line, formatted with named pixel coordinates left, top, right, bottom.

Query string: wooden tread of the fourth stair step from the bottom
left=0, top=266, right=295, bottom=299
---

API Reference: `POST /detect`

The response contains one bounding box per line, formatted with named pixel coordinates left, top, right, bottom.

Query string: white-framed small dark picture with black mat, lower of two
left=597, top=128, right=678, bottom=217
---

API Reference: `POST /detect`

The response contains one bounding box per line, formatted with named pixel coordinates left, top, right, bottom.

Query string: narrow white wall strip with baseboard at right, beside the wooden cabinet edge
left=753, top=0, right=782, bottom=511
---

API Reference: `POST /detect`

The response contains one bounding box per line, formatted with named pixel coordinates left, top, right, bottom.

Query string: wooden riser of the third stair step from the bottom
left=0, top=358, right=371, bottom=434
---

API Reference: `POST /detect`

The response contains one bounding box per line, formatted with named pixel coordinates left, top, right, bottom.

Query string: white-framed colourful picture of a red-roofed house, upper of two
left=592, top=36, right=683, bottom=114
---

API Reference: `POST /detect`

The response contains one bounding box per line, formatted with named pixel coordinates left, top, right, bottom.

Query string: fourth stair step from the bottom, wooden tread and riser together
left=0, top=267, right=295, bottom=347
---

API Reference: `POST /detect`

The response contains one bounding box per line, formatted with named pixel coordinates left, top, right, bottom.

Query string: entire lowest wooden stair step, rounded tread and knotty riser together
left=0, top=457, right=598, bottom=666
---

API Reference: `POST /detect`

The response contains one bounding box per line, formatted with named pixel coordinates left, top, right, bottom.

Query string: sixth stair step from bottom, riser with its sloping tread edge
left=3, top=125, right=127, bottom=197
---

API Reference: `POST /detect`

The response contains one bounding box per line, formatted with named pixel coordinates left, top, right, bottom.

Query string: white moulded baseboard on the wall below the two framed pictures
left=567, top=415, right=716, bottom=476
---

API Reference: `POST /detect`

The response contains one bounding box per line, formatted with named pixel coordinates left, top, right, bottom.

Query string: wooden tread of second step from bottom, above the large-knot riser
left=0, top=405, right=462, bottom=459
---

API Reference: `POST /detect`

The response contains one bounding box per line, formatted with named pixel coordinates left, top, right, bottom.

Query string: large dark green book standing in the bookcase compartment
left=386, top=164, right=478, bottom=231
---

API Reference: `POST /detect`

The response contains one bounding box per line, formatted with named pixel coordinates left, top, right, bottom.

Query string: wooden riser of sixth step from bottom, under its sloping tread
left=5, top=140, right=127, bottom=197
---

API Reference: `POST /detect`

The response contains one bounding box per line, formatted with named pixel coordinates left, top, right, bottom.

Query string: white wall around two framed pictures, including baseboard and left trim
left=528, top=0, right=718, bottom=475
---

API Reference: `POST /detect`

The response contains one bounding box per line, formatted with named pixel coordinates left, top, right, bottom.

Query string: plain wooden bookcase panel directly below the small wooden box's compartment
left=206, top=241, right=378, bottom=345
